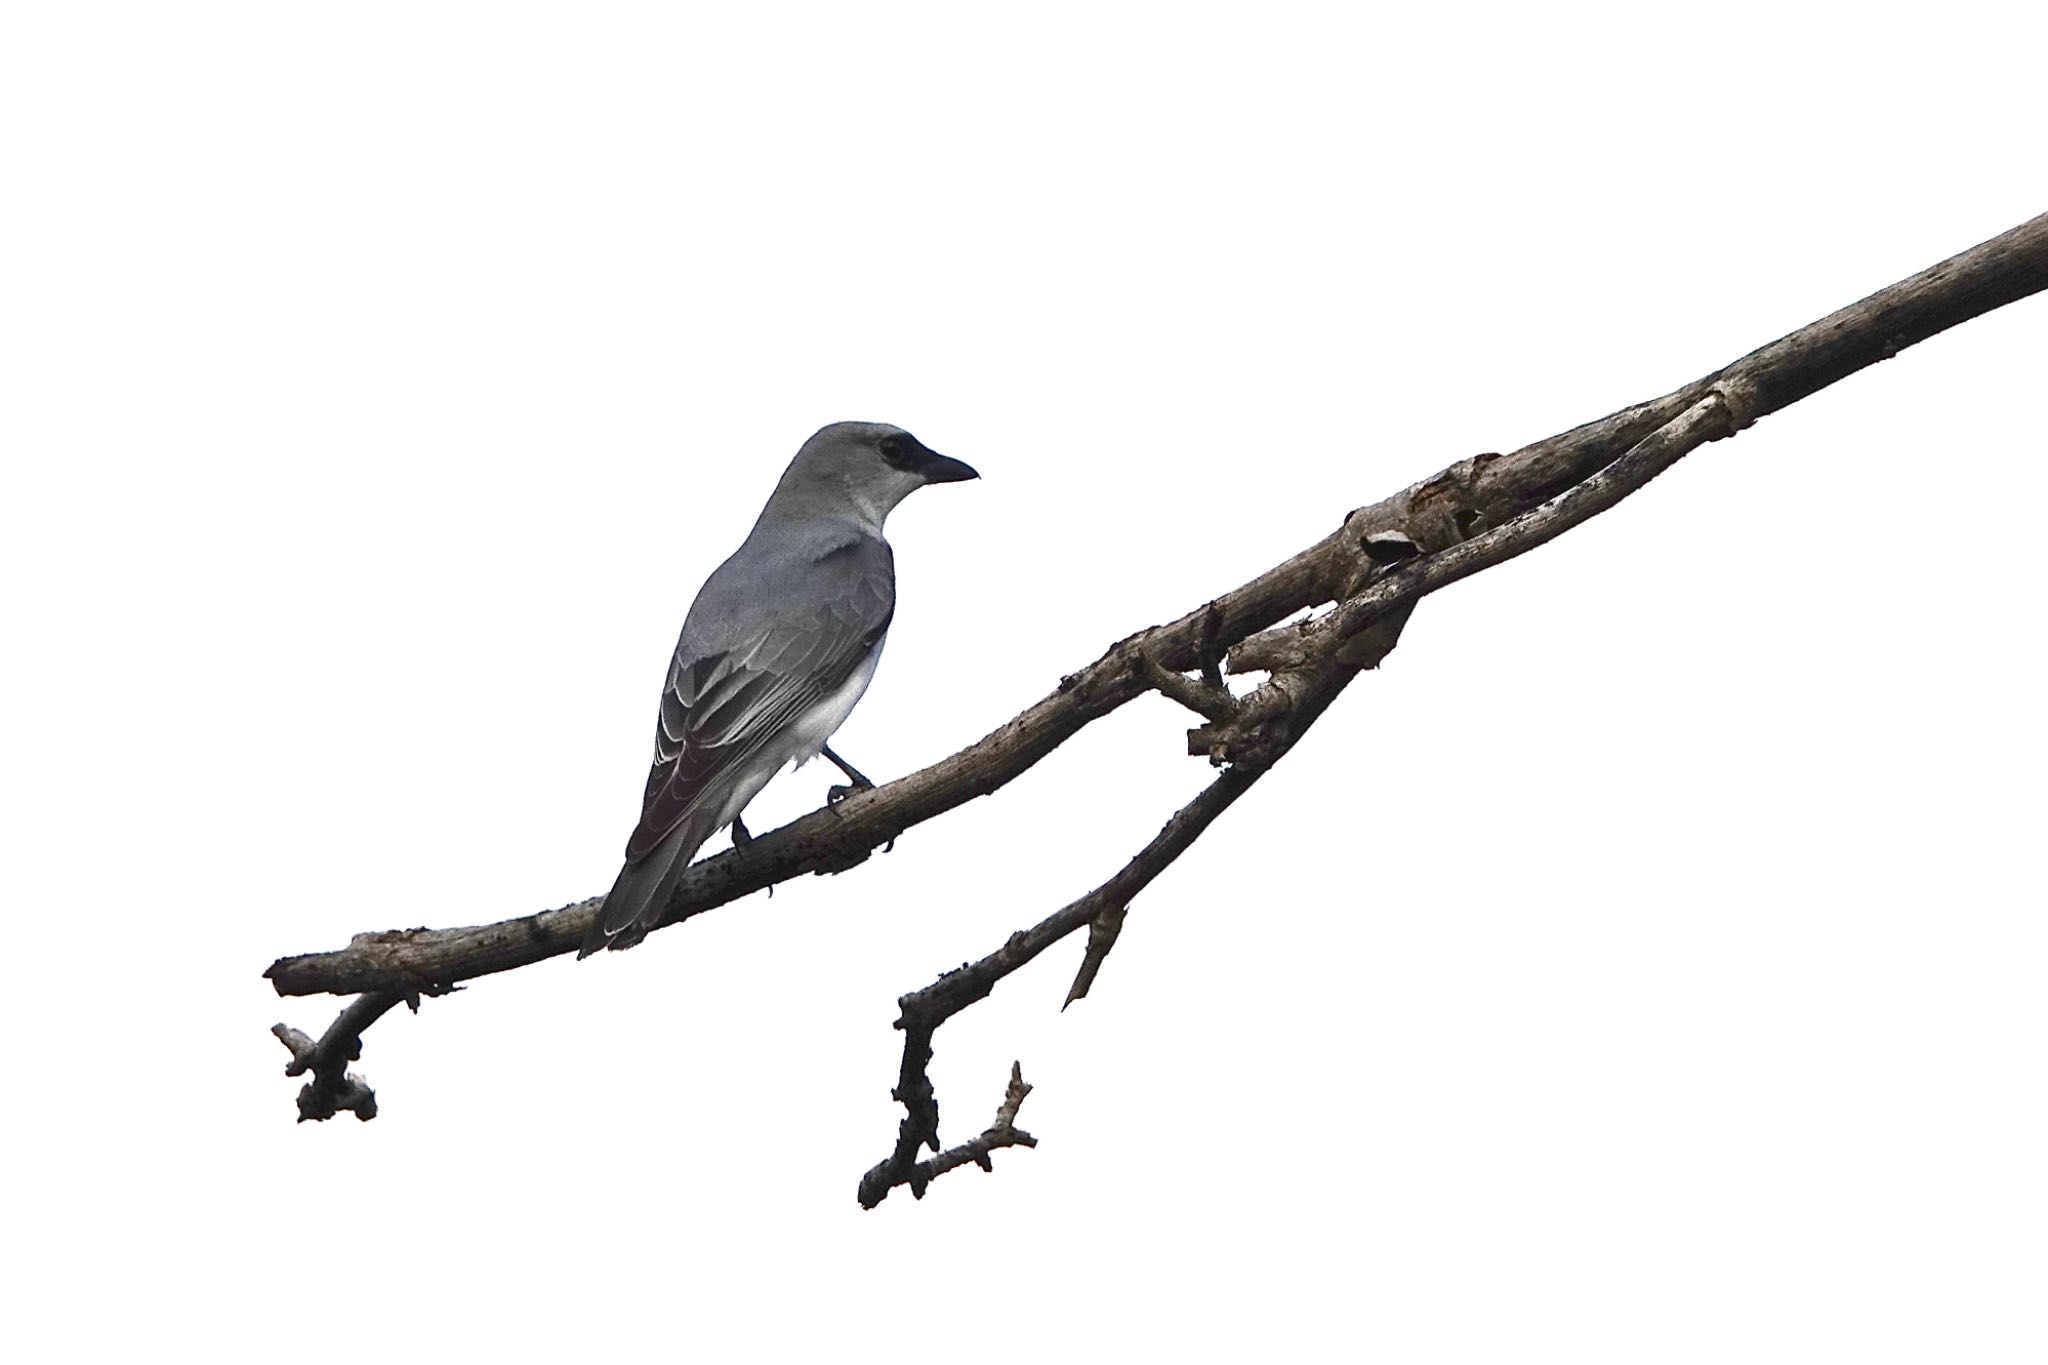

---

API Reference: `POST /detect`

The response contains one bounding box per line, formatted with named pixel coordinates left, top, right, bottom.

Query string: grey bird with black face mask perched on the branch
left=578, top=422, right=981, bottom=958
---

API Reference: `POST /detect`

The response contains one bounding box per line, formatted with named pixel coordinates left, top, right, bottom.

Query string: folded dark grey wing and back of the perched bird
left=627, top=534, right=895, bottom=864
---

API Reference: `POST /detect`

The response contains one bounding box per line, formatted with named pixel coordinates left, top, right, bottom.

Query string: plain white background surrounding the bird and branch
left=0, top=4, right=2048, bottom=1363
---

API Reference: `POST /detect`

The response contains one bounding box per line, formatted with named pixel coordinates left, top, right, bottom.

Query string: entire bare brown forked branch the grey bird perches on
left=266, top=215, right=2048, bottom=1205
